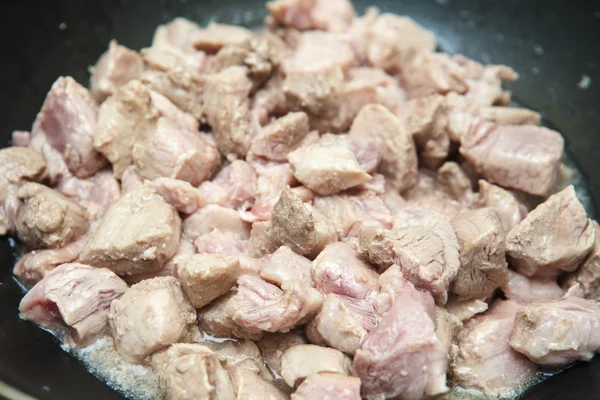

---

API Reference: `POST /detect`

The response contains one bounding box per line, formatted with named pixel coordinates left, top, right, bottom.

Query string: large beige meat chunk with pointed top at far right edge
left=506, top=186, right=596, bottom=276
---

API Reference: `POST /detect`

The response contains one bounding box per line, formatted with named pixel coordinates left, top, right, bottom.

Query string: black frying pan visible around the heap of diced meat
left=0, top=0, right=600, bottom=400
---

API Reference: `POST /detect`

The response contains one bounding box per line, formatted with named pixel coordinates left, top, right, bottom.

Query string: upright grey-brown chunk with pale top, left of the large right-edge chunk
left=450, top=208, right=508, bottom=299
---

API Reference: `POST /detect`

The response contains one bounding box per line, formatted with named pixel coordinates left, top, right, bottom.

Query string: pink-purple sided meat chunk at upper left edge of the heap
left=31, top=77, right=106, bottom=178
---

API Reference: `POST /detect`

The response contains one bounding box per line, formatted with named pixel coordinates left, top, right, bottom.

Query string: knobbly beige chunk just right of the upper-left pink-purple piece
left=93, top=80, right=157, bottom=179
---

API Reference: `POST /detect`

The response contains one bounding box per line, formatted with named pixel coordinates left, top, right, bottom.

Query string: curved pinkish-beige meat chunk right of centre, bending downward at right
left=349, top=104, right=417, bottom=191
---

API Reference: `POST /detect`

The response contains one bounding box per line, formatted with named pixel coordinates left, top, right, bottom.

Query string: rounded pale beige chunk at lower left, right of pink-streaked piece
left=108, top=276, right=196, bottom=363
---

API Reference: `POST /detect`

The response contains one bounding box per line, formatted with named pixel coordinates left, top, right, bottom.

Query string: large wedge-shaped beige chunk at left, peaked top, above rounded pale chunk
left=79, top=185, right=181, bottom=275
